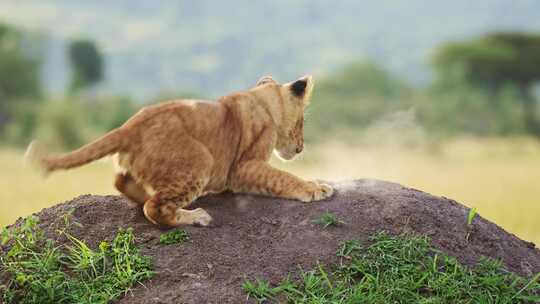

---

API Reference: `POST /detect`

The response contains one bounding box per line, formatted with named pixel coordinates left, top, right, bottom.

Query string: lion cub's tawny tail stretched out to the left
left=25, top=129, right=124, bottom=176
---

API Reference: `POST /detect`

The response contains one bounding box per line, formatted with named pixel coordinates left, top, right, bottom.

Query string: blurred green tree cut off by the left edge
left=0, top=23, right=41, bottom=129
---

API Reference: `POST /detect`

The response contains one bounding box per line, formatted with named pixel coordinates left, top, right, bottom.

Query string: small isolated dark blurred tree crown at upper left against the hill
left=69, top=39, right=104, bottom=93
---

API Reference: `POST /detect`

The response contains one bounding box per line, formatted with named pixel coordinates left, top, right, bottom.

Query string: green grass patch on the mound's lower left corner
left=0, top=217, right=153, bottom=303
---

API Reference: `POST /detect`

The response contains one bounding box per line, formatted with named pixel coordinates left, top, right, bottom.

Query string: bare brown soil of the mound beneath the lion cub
left=12, top=180, right=540, bottom=303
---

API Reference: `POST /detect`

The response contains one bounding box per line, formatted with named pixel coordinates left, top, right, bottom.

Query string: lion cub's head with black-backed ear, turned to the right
left=257, top=75, right=313, bottom=160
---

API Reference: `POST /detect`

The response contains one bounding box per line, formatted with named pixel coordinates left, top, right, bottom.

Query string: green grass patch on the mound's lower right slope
left=243, top=233, right=540, bottom=304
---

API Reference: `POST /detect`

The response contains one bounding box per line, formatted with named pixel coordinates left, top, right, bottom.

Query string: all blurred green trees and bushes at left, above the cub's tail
left=0, top=24, right=134, bottom=149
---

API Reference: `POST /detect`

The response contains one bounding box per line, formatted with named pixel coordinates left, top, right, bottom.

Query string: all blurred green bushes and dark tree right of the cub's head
left=307, top=33, right=540, bottom=140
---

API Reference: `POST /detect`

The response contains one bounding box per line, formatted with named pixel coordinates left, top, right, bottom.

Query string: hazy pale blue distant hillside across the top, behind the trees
left=0, top=0, right=540, bottom=97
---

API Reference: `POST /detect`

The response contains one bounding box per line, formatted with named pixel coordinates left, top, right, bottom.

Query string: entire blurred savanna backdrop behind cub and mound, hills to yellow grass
left=0, top=0, right=540, bottom=244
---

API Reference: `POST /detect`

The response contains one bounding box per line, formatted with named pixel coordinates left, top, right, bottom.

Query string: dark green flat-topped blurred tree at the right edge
left=434, top=33, right=540, bottom=136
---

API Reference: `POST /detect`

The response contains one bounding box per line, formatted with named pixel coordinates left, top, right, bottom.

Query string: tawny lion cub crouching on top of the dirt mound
left=27, top=76, right=333, bottom=226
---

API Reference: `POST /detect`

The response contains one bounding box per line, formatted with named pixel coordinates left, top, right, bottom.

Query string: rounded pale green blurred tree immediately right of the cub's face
left=306, top=62, right=411, bottom=140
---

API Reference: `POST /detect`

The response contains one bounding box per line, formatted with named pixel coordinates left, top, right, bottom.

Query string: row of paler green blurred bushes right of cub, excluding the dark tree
left=306, top=65, right=528, bottom=141
